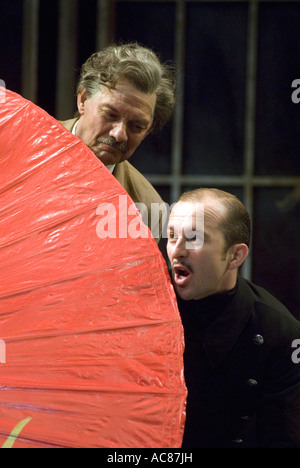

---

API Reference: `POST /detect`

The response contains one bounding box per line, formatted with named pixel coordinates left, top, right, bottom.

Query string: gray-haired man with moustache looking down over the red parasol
left=62, top=43, right=175, bottom=241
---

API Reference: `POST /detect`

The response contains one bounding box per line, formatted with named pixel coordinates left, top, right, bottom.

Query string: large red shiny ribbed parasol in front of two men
left=0, top=91, right=186, bottom=448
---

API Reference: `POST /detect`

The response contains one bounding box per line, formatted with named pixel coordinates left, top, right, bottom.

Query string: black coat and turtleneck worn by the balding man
left=178, top=278, right=300, bottom=448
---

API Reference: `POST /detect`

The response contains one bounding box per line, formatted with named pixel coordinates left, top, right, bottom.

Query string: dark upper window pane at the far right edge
left=256, top=2, right=300, bottom=176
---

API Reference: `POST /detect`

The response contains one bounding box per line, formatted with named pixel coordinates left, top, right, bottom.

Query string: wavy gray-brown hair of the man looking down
left=77, top=43, right=175, bottom=130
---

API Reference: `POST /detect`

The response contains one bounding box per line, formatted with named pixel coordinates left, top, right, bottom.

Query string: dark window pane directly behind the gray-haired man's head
left=115, top=1, right=175, bottom=174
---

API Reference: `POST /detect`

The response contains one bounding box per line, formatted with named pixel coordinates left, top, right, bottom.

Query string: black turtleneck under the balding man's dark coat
left=173, top=280, right=238, bottom=447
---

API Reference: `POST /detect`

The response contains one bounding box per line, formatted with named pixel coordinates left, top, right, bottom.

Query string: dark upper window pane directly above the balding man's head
left=183, top=2, right=248, bottom=175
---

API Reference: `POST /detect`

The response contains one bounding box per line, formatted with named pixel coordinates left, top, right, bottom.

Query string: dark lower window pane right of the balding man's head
left=252, top=187, right=300, bottom=319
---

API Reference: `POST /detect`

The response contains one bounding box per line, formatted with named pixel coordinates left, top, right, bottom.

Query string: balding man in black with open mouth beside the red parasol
left=167, top=189, right=300, bottom=448
